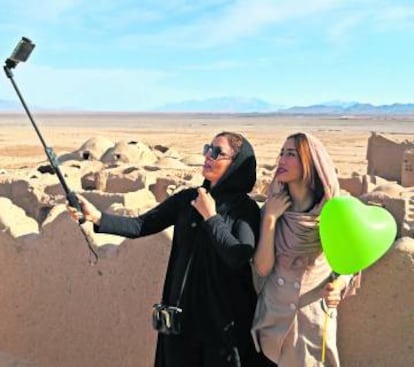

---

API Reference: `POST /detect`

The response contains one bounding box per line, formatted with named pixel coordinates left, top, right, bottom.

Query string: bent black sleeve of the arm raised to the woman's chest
left=204, top=203, right=260, bottom=268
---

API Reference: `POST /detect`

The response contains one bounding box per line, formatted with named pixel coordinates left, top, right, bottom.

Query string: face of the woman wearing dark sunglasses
left=202, top=136, right=234, bottom=186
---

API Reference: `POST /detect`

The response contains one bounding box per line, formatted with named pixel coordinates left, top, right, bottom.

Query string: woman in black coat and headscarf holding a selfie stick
left=69, top=132, right=268, bottom=367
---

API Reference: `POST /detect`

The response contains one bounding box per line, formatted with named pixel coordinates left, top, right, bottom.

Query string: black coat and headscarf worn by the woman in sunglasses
left=95, top=140, right=260, bottom=367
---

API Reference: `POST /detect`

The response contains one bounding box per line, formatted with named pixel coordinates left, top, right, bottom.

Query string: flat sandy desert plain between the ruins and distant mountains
left=0, top=113, right=414, bottom=177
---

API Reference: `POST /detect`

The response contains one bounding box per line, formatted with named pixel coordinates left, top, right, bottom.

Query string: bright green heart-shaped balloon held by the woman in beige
left=319, top=196, right=397, bottom=274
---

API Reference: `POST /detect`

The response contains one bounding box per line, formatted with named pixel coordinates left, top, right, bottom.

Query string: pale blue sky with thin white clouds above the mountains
left=0, top=0, right=414, bottom=111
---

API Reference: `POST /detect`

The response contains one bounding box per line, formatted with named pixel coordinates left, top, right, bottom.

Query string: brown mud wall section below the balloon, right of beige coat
left=338, top=237, right=414, bottom=367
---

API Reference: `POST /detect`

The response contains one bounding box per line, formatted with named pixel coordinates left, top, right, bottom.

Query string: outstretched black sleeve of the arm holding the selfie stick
left=94, top=194, right=180, bottom=238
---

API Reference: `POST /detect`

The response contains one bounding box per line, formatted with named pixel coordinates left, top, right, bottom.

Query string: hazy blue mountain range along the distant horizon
left=0, top=97, right=414, bottom=117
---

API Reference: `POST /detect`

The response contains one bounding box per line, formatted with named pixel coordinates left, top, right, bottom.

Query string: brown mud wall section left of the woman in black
left=0, top=207, right=170, bottom=367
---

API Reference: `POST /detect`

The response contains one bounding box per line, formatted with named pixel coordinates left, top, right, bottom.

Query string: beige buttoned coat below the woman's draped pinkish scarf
left=252, top=253, right=339, bottom=367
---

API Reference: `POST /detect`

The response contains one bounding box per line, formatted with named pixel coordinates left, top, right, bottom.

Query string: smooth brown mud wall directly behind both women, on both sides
left=0, top=205, right=414, bottom=367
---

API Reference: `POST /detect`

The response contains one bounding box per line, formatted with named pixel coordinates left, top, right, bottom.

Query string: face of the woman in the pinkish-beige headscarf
left=275, top=139, right=303, bottom=184
